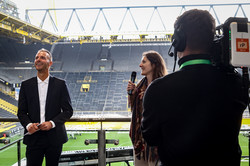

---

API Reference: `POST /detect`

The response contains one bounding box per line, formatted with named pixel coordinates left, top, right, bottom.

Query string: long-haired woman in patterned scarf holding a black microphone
left=127, top=50, right=167, bottom=166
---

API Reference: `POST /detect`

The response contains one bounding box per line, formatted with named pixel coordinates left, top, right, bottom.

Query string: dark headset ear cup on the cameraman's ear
left=172, top=29, right=186, bottom=52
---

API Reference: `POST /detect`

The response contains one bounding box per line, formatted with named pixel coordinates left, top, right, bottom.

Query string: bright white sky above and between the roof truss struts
left=11, top=0, right=250, bottom=35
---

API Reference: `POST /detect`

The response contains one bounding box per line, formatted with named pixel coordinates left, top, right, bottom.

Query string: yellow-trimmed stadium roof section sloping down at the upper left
left=0, top=12, right=61, bottom=44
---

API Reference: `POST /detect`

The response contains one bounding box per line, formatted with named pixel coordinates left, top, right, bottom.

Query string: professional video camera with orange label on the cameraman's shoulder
left=212, top=17, right=250, bottom=68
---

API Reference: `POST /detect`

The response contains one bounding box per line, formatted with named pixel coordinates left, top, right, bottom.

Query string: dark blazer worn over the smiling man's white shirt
left=17, top=76, right=73, bottom=145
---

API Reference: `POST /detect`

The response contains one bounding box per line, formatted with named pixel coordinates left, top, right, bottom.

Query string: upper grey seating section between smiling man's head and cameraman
left=53, top=43, right=173, bottom=72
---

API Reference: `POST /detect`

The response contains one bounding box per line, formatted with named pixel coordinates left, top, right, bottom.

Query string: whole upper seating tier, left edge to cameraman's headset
left=0, top=37, right=173, bottom=72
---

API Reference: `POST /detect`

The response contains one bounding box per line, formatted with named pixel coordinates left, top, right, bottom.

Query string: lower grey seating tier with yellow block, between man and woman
left=52, top=72, right=141, bottom=114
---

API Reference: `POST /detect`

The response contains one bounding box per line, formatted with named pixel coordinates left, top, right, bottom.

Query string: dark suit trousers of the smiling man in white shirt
left=26, top=131, right=62, bottom=166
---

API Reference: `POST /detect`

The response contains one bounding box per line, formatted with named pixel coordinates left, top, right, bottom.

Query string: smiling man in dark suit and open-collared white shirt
left=17, top=49, right=73, bottom=166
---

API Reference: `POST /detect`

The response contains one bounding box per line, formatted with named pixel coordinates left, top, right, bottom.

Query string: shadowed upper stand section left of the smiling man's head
left=0, top=37, right=51, bottom=83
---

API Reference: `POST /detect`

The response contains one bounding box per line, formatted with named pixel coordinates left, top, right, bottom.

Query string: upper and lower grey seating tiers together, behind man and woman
left=0, top=37, right=173, bottom=115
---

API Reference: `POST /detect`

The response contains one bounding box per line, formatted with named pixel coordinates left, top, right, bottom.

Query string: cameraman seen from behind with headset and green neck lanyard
left=142, top=9, right=248, bottom=166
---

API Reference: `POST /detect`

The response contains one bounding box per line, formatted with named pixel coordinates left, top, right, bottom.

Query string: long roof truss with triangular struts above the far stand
left=25, top=3, right=250, bottom=44
